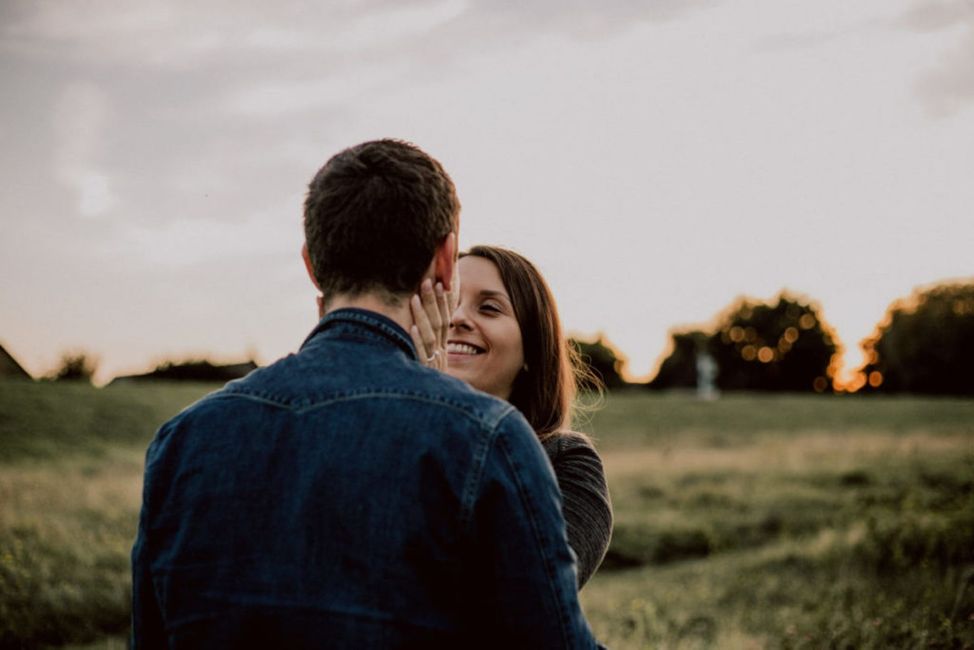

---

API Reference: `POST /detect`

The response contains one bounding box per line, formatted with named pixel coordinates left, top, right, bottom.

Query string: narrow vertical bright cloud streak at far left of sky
left=54, top=82, right=116, bottom=217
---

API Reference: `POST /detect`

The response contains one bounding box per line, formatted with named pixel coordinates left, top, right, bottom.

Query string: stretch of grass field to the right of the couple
left=582, top=394, right=974, bottom=648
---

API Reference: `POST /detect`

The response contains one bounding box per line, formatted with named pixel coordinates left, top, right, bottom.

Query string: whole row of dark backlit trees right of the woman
left=573, top=282, right=974, bottom=395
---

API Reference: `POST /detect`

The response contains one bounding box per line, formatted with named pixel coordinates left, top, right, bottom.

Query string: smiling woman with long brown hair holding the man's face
left=411, top=246, right=612, bottom=589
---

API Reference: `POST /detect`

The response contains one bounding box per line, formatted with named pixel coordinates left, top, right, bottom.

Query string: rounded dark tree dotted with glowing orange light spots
left=709, top=292, right=838, bottom=392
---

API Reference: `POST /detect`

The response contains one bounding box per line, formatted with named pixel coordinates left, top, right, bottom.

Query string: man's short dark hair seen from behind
left=304, top=140, right=460, bottom=302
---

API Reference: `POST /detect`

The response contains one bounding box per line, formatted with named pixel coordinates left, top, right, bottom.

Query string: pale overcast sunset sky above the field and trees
left=0, top=0, right=974, bottom=383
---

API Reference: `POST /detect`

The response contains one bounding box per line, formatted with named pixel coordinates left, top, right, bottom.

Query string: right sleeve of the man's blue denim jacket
left=472, top=412, right=595, bottom=648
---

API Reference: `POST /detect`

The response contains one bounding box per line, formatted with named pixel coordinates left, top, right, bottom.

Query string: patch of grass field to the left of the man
left=0, top=382, right=214, bottom=648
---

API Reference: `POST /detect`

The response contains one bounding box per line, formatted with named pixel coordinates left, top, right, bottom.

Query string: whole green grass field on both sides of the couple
left=0, top=382, right=974, bottom=649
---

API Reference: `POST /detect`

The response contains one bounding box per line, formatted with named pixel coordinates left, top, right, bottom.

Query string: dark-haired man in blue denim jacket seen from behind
left=132, top=140, right=594, bottom=648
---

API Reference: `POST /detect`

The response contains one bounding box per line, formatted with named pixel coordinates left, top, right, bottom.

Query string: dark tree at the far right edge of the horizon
left=860, top=282, right=974, bottom=395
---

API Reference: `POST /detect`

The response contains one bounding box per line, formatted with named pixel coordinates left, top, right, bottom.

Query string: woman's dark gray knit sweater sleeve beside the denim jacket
left=541, top=431, right=612, bottom=589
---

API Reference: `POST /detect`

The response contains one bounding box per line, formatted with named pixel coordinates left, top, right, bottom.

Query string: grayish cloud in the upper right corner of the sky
left=897, top=0, right=974, bottom=117
